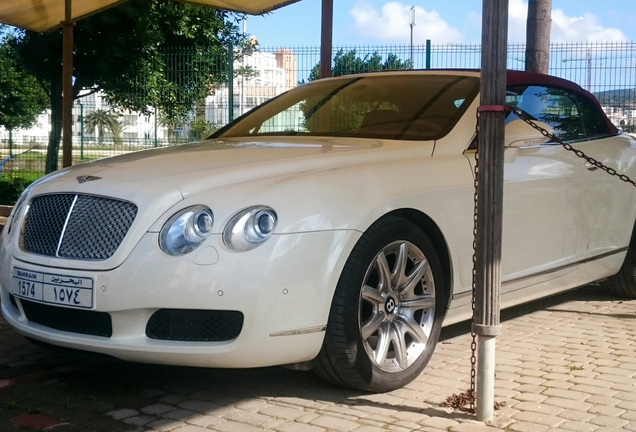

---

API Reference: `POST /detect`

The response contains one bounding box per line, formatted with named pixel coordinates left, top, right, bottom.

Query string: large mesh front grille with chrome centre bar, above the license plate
left=22, top=194, right=137, bottom=261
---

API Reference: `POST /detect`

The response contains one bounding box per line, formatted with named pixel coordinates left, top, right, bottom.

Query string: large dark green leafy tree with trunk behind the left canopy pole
left=10, top=0, right=249, bottom=172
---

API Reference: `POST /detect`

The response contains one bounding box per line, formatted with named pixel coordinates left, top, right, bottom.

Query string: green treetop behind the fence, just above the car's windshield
left=307, top=49, right=413, bottom=81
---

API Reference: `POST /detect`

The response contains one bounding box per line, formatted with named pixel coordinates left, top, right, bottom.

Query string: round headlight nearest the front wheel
left=223, top=206, right=278, bottom=252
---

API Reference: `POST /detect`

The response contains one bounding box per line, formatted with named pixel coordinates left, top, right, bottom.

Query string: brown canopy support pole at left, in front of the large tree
left=62, top=0, right=73, bottom=168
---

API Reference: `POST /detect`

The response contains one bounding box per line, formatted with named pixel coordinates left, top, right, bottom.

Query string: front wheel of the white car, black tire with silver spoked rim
left=314, top=216, right=448, bottom=392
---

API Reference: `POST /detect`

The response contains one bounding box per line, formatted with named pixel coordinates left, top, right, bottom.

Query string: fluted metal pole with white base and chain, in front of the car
left=473, top=0, right=508, bottom=421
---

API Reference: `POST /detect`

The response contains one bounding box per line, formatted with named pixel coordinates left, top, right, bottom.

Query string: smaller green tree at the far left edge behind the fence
left=0, top=32, right=48, bottom=150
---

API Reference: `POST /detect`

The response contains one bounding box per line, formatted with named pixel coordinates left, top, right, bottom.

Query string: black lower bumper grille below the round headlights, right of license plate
left=146, top=309, right=243, bottom=342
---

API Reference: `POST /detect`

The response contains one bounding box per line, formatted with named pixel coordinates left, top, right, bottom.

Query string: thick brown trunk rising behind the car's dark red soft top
left=526, top=0, right=552, bottom=74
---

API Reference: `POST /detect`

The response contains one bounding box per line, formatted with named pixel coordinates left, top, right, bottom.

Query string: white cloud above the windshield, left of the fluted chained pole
left=350, top=0, right=463, bottom=44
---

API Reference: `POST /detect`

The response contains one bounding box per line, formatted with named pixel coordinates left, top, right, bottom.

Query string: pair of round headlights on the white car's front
left=159, top=206, right=278, bottom=256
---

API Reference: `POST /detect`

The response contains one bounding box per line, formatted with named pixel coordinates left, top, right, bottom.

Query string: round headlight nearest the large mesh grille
left=159, top=206, right=214, bottom=256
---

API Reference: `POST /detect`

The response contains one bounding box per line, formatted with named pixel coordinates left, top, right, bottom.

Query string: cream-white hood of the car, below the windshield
left=33, top=139, right=421, bottom=201
